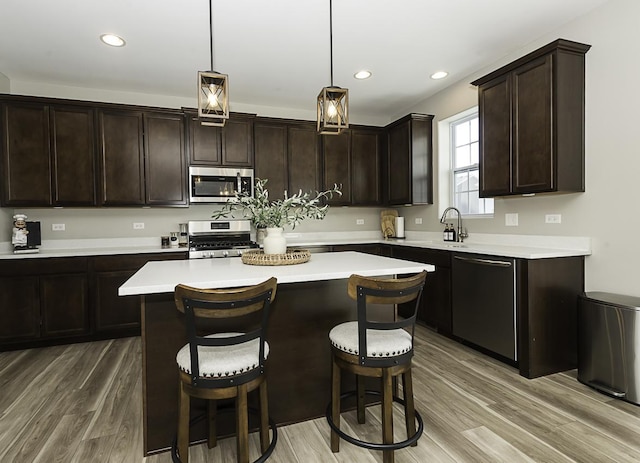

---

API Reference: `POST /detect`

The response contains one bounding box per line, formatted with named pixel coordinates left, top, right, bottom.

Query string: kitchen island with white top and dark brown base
left=119, top=252, right=434, bottom=455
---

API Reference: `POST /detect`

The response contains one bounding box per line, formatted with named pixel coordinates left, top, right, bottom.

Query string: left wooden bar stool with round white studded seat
left=172, top=278, right=277, bottom=463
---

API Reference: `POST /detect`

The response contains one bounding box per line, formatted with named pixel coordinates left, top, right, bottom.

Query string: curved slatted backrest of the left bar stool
left=174, top=278, right=277, bottom=388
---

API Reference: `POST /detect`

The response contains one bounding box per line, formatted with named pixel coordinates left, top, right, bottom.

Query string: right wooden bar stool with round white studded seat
left=326, top=272, right=427, bottom=463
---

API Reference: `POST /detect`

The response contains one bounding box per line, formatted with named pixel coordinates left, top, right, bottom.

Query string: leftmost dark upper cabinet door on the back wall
left=2, top=102, right=51, bottom=206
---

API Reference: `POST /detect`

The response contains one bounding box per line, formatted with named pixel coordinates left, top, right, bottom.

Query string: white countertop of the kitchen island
left=118, top=251, right=435, bottom=296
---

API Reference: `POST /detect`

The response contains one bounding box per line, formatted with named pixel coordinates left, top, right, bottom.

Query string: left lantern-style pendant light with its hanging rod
left=198, top=0, right=229, bottom=127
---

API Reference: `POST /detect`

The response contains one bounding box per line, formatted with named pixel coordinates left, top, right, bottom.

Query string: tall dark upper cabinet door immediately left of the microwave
left=144, top=113, right=187, bottom=206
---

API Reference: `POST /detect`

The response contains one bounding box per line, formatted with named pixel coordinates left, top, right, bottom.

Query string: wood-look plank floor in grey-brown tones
left=0, top=327, right=640, bottom=463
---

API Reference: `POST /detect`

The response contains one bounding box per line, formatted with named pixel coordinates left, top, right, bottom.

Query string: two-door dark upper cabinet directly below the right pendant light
left=322, top=127, right=382, bottom=206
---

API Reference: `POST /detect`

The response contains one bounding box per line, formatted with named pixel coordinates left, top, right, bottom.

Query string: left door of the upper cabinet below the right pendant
left=322, top=132, right=351, bottom=206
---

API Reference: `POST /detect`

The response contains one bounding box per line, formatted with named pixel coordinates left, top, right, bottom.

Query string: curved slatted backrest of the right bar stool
left=347, top=271, right=427, bottom=367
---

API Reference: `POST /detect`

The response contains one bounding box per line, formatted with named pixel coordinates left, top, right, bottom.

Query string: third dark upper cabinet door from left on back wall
left=99, top=110, right=145, bottom=206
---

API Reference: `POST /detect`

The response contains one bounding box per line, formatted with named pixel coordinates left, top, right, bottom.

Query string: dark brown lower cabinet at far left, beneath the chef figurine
left=0, top=257, right=90, bottom=349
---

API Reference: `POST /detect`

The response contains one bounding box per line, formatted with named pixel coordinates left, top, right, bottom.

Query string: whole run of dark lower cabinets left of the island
left=0, top=251, right=187, bottom=351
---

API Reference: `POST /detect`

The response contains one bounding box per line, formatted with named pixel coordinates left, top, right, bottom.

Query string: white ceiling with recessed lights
left=0, top=0, right=607, bottom=122
